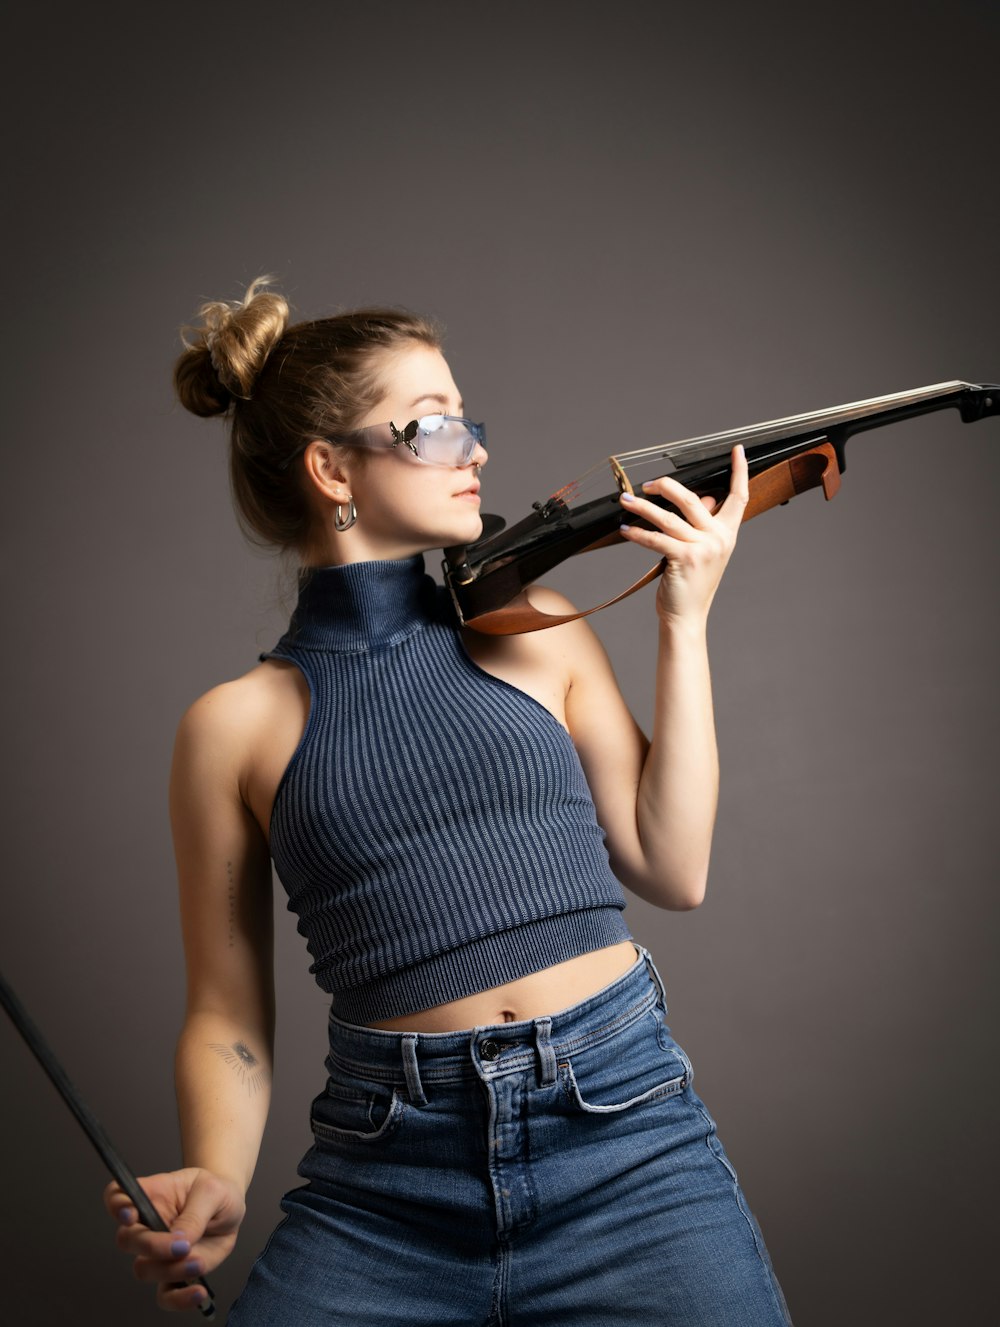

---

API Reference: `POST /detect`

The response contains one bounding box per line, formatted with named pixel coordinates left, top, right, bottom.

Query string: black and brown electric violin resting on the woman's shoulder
left=443, top=382, right=1000, bottom=636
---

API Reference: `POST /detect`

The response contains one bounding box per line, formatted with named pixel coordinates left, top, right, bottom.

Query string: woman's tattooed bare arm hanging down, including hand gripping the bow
left=106, top=679, right=275, bottom=1308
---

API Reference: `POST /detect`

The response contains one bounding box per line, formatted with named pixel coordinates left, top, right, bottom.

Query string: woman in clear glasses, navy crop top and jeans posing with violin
left=106, top=280, right=788, bottom=1327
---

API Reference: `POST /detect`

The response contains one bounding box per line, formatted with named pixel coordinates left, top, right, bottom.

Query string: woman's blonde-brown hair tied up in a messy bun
left=174, top=276, right=442, bottom=552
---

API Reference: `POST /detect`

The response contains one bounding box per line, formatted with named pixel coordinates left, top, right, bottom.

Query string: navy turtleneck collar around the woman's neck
left=286, top=553, right=436, bottom=653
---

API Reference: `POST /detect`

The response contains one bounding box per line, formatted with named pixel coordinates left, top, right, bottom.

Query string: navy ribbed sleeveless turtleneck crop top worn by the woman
left=261, top=555, right=629, bottom=1023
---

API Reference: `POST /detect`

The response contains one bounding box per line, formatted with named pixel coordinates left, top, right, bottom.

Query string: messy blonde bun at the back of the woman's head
left=174, top=276, right=288, bottom=415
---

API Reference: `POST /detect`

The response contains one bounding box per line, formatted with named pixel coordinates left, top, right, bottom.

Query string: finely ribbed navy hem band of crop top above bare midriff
left=324, top=906, right=631, bottom=1026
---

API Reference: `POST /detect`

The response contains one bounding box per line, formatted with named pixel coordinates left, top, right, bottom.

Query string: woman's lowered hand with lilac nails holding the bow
left=105, top=1166, right=247, bottom=1311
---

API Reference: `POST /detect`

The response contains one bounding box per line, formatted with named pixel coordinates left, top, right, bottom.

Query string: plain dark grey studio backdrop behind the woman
left=0, top=0, right=1000, bottom=1327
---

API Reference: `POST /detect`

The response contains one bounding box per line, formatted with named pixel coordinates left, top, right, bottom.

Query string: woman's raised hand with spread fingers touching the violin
left=621, top=447, right=749, bottom=625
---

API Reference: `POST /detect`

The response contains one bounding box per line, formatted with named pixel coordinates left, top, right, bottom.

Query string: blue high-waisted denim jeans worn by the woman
left=228, top=949, right=789, bottom=1327
